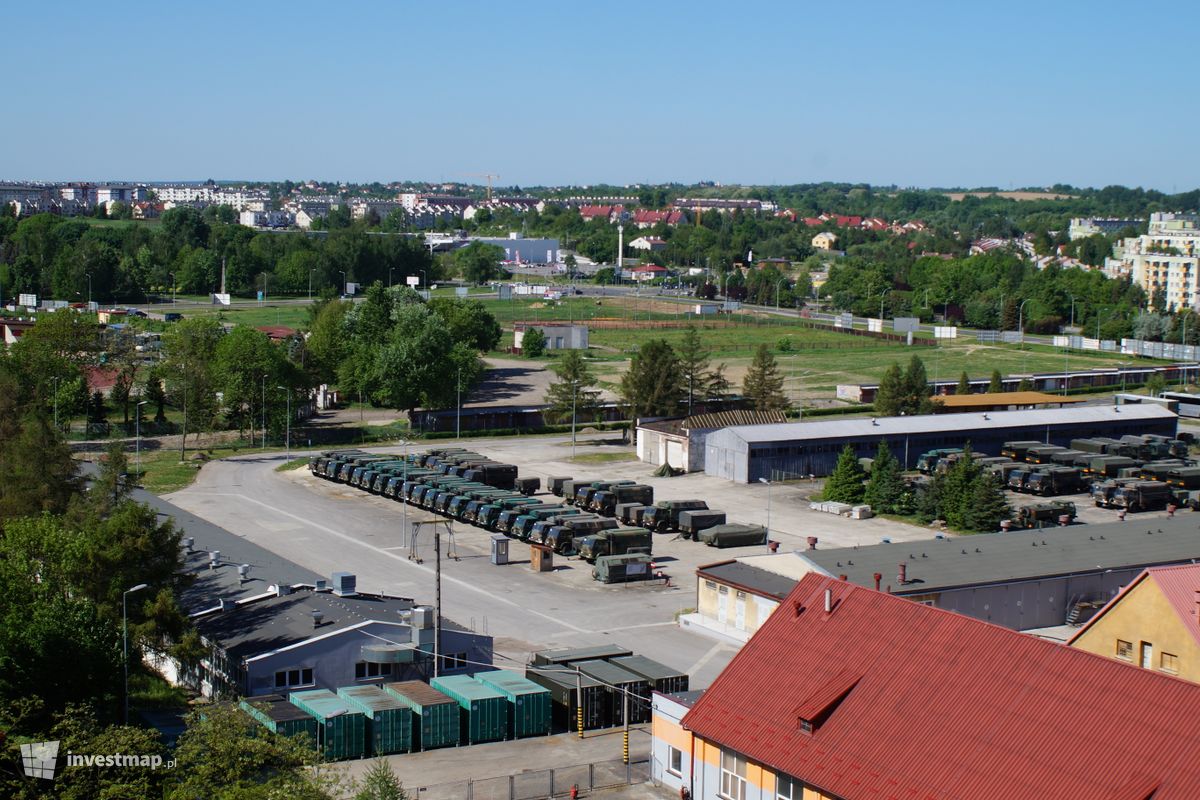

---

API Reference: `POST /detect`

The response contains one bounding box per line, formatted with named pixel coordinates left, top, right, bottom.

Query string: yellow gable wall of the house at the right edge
left=1070, top=578, right=1200, bottom=682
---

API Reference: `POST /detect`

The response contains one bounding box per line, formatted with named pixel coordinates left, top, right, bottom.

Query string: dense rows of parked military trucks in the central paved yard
left=308, top=447, right=767, bottom=579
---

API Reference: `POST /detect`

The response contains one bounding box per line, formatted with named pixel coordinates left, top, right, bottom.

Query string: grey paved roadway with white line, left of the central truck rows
left=167, top=456, right=734, bottom=687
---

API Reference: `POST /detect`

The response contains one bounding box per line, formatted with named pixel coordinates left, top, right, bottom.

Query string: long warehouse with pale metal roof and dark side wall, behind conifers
left=704, top=404, right=1178, bottom=483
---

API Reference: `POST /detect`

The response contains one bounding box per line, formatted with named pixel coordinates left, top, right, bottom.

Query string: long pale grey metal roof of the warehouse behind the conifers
left=708, top=404, right=1176, bottom=443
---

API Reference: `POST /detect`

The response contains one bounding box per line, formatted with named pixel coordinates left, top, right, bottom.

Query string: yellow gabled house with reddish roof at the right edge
left=1068, top=565, right=1200, bottom=682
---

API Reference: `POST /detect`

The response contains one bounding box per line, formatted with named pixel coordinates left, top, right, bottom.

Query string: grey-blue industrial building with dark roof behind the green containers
left=147, top=495, right=492, bottom=697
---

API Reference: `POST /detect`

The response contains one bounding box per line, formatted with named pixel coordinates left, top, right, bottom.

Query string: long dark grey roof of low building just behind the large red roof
left=796, top=516, right=1200, bottom=595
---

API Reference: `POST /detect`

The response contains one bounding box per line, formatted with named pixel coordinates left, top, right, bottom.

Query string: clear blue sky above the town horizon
left=0, top=0, right=1200, bottom=192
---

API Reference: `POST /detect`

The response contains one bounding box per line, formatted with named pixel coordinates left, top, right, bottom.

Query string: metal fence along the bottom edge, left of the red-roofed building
left=406, top=757, right=650, bottom=800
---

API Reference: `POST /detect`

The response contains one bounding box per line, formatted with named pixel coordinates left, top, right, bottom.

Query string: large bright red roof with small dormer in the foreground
left=683, top=575, right=1200, bottom=800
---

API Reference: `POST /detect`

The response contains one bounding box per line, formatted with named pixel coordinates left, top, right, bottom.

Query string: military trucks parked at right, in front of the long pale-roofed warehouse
left=917, top=434, right=1200, bottom=515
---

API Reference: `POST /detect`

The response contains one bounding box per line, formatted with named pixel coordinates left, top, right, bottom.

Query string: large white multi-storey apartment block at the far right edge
left=1104, top=211, right=1200, bottom=311
